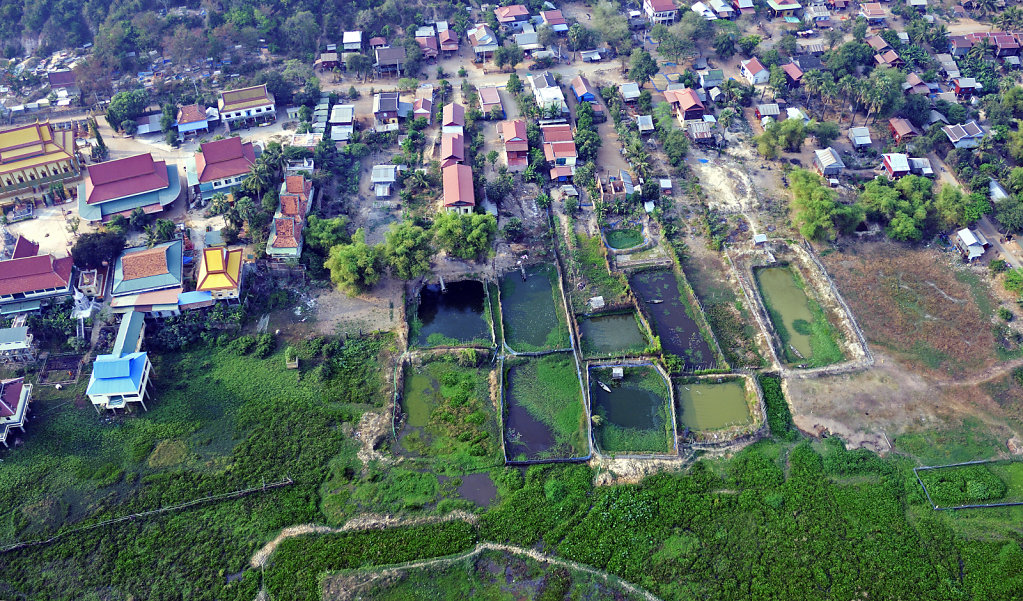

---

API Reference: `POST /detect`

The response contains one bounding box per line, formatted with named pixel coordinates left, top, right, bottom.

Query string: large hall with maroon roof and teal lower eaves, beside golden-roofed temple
left=78, top=153, right=181, bottom=223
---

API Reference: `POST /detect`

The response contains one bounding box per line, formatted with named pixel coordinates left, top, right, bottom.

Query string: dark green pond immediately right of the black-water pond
left=501, top=263, right=572, bottom=352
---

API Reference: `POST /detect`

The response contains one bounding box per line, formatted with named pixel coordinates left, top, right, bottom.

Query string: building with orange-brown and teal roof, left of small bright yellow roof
left=110, top=240, right=184, bottom=317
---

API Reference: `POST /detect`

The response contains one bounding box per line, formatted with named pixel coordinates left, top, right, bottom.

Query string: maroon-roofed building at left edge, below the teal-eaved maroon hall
left=0, top=237, right=75, bottom=316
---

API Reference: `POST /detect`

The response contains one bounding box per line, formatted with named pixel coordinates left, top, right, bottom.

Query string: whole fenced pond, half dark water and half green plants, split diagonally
left=503, top=352, right=589, bottom=462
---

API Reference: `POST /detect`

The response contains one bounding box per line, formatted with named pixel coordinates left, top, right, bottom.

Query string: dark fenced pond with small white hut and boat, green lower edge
left=589, top=366, right=676, bottom=455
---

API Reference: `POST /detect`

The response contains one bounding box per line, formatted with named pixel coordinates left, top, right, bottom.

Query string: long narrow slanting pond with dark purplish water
left=629, top=269, right=717, bottom=370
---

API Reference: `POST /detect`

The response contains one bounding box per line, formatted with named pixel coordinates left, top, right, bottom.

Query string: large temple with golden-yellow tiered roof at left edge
left=0, top=123, right=82, bottom=195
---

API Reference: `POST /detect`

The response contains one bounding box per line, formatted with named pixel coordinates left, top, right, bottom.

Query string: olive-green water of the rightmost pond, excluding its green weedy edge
left=754, top=267, right=813, bottom=359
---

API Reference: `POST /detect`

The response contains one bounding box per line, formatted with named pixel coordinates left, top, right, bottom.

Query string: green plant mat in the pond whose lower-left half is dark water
left=505, top=353, right=588, bottom=459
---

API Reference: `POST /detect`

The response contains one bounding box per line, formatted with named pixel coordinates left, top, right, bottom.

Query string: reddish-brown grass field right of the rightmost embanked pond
left=822, top=243, right=997, bottom=376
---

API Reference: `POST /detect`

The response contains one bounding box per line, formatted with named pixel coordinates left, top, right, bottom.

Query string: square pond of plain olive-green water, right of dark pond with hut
left=672, top=376, right=762, bottom=440
